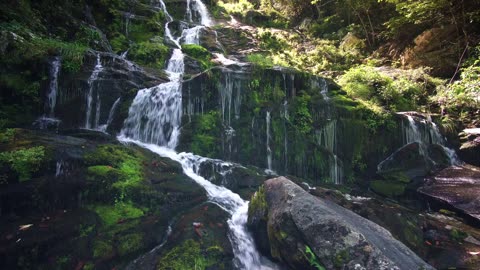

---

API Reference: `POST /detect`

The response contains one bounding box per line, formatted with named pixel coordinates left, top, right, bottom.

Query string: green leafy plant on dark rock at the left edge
left=0, top=146, right=45, bottom=182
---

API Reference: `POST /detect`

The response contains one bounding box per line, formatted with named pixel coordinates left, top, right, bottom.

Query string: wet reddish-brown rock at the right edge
left=418, top=166, right=480, bottom=223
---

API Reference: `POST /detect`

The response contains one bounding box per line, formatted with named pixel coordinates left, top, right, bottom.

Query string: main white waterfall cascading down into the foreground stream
left=118, top=0, right=274, bottom=269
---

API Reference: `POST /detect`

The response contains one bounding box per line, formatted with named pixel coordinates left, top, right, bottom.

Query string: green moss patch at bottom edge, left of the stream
left=157, top=239, right=217, bottom=270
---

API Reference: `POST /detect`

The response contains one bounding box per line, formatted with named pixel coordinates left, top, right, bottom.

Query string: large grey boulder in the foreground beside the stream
left=249, top=177, right=433, bottom=269
